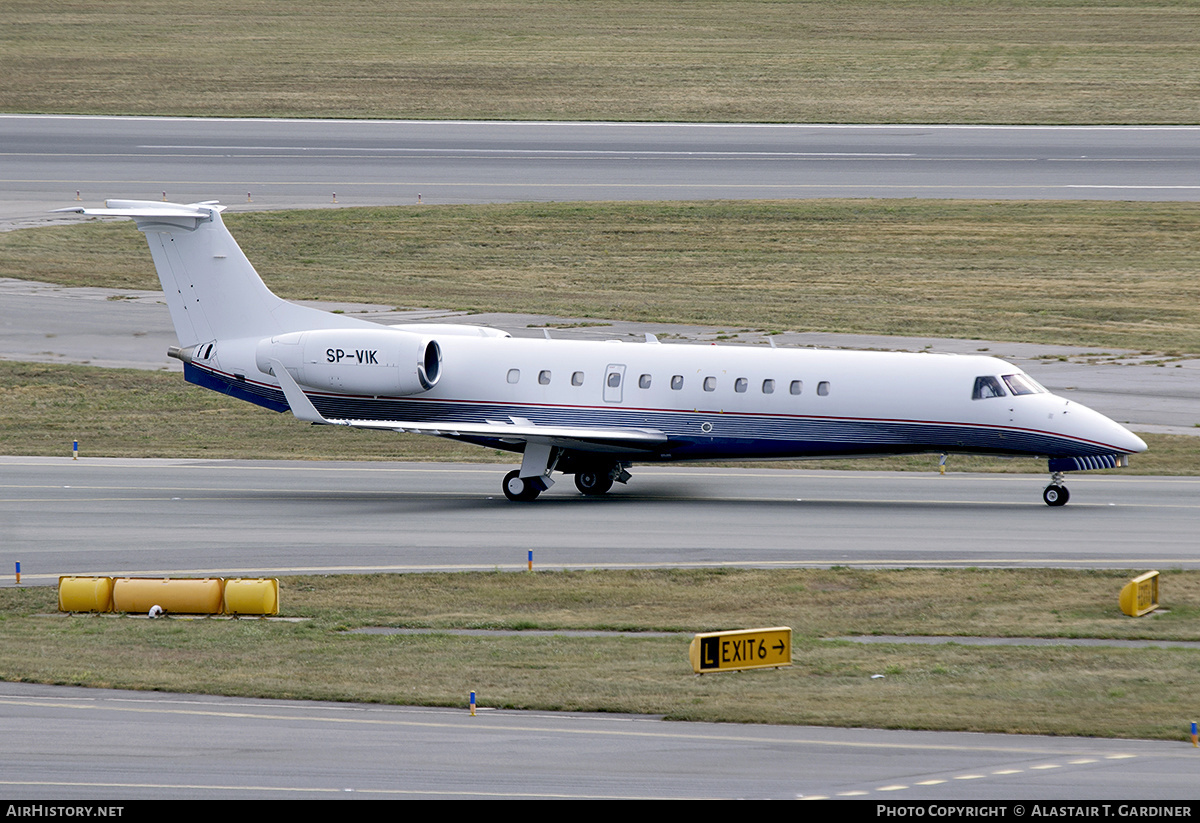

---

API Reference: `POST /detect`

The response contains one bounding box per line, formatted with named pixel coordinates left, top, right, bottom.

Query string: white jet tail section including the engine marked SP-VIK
left=59, top=200, right=451, bottom=412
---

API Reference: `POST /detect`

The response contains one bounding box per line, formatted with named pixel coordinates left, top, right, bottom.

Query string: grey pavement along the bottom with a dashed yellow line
left=0, top=683, right=1196, bottom=801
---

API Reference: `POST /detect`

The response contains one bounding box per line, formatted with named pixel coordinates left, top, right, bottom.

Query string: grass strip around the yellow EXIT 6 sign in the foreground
left=7, top=567, right=1200, bottom=740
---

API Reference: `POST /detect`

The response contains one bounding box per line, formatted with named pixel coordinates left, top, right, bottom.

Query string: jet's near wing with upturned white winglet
left=271, top=360, right=667, bottom=453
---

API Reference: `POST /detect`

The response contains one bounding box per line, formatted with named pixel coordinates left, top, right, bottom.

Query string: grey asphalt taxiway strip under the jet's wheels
left=0, top=457, right=1200, bottom=584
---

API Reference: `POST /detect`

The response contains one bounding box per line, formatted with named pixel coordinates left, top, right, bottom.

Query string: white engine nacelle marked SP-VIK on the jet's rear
left=254, top=329, right=442, bottom=396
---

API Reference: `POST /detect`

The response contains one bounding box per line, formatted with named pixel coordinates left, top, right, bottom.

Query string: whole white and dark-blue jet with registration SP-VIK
left=59, top=200, right=1146, bottom=506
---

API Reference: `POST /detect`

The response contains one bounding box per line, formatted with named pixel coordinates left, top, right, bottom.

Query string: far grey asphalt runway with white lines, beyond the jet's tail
left=0, top=115, right=1200, bottom=224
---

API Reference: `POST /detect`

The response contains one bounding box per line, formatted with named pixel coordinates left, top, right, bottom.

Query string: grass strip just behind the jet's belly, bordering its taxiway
left=0, top=360, right=1200, bottom=475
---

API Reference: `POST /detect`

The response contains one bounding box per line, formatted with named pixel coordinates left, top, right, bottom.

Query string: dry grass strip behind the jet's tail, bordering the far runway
left=7, top=200, right=1200, bottom=355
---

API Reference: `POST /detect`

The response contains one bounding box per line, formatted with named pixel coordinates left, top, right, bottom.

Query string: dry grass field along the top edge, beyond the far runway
left=0, top=0, right=1200, bottom=124
